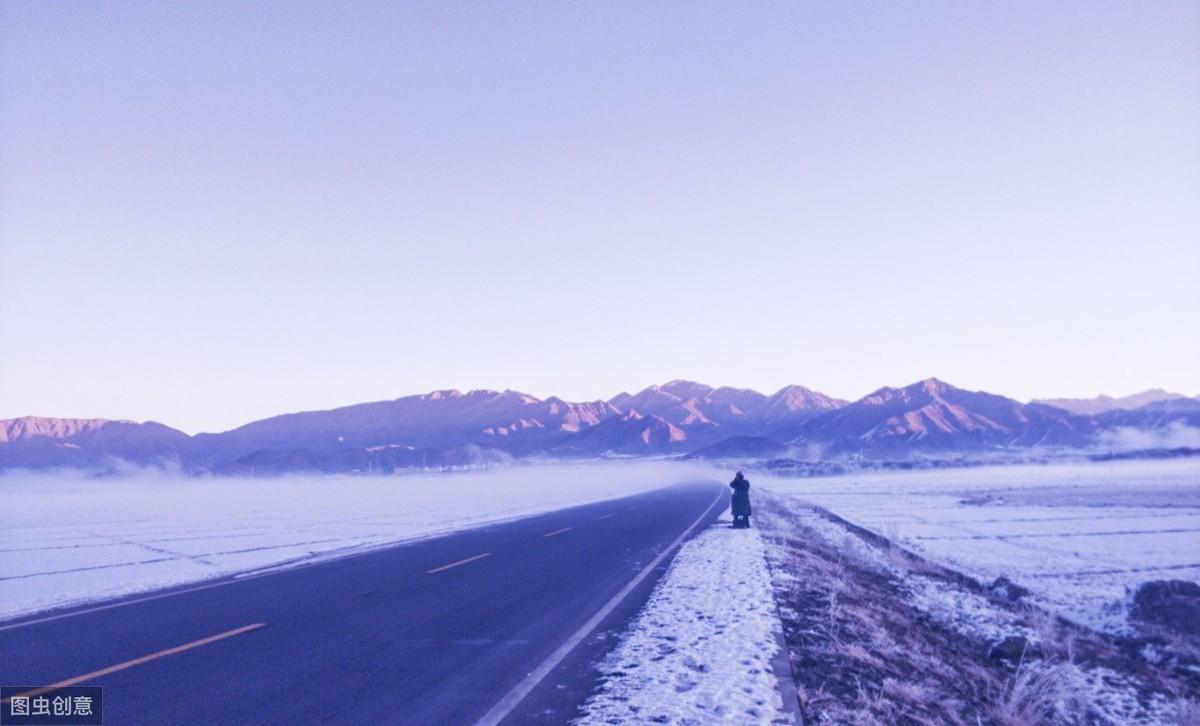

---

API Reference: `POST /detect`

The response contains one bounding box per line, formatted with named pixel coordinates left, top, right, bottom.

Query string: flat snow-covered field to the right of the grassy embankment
left=755, top=458, right=1200, bottom=632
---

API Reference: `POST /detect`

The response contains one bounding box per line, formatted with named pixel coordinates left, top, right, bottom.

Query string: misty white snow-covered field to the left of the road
left=0, top=463, right=712, bottom=618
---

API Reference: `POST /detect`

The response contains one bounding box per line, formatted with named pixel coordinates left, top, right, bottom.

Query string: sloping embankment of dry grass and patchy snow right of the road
left=758, top=493, right=1196, bottom=726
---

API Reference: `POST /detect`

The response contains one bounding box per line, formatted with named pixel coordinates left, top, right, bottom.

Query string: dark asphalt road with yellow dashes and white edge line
left=0, top=484, right=727, bottom=725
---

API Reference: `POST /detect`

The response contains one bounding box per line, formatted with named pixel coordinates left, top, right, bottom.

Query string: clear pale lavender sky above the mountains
left=0, top=1, right=1200, bottom=432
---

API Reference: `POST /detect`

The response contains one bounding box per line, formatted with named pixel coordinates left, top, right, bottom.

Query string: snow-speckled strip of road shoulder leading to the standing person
left=577, top=512, right=792, bottom=725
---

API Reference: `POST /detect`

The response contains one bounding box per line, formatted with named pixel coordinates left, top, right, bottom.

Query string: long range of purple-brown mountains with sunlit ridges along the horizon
left=0, top=378, right=1200, bottom=474
